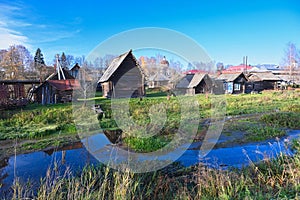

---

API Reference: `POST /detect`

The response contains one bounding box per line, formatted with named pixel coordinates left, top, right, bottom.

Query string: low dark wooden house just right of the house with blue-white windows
left=248, top=71, right=281, bottom=92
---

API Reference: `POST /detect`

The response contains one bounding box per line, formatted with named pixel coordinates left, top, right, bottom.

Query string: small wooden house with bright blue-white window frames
left=216, top=72, right=248, bottom=94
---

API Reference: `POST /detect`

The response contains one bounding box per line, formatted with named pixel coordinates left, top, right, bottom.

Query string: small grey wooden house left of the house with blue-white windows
left=176, top=73, right=213, bottom=95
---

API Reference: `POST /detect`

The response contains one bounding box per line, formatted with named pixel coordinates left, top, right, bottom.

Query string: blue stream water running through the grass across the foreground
left=0, top=130, right=300, bottom=197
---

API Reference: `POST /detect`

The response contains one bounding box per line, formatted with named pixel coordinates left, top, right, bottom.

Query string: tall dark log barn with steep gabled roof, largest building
left=98, top=50, right=145, bottom=98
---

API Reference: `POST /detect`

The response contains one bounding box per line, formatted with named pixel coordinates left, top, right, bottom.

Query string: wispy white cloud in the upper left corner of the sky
left=0, top=2, right=82, bottom=52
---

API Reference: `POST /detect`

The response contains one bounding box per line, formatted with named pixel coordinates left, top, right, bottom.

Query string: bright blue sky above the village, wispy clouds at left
left=0, top=0, right=300, bottom=64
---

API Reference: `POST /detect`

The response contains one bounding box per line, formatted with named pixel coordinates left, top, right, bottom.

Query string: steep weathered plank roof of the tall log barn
left=98, top=50, right=141, bottom=83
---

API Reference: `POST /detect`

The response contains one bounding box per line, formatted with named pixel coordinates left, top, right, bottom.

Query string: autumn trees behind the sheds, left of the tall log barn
left=0, top=45, right=115, bottom=80
